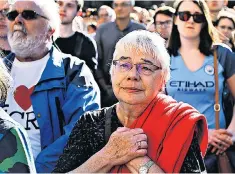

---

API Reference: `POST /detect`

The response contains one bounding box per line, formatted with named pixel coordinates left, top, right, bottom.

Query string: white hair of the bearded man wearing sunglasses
left=8, top=0, right=61, bottom=40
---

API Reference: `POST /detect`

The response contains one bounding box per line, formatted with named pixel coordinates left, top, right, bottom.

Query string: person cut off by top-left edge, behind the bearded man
left=0, top=0, right=11, bottom=57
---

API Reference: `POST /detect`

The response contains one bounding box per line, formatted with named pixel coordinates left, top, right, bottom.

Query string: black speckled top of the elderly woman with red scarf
left=53, top=106, right=205, bottom=173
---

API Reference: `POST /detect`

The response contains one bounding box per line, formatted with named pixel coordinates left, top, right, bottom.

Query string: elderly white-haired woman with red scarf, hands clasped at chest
left=54, top=30, right=208, bottom=173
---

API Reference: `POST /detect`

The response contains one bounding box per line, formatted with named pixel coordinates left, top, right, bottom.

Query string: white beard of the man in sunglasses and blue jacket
left=8, top=27, right=46, bottom=58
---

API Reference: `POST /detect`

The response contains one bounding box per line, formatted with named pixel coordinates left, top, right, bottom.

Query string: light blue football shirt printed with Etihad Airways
left=166, top=46, right=235, bottom=129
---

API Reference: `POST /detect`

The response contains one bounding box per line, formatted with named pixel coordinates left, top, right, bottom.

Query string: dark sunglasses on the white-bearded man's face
left=6, top=10, right=47, bottom=21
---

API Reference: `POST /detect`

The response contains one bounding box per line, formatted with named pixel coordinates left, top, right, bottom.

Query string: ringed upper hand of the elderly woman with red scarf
left=103, top=127, right=148, bottom=166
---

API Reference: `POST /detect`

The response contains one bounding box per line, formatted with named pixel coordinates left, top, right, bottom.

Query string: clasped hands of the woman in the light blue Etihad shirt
left=209, top=129, right=233, bottom=155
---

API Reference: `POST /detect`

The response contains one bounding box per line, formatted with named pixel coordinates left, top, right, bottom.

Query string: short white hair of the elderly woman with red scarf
left=110, top=30, right=170, bottom=83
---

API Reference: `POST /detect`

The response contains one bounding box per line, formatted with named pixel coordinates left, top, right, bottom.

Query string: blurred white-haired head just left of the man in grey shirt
left=97, top=5, right=116, bottom=27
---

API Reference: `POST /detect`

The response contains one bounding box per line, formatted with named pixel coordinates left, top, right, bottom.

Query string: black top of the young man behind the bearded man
left=55, top=32, right=98, bottom=72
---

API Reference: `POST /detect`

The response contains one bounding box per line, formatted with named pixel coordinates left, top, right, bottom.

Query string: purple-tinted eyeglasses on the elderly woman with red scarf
left=113, top=60, right=162, bottom=75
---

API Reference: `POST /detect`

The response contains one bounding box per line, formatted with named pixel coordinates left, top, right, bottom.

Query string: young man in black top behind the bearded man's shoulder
left=55, top=0, right=98, bottom=75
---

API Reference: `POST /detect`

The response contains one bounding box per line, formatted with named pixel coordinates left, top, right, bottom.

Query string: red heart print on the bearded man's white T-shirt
left=14, top=85, right=34, bottom=111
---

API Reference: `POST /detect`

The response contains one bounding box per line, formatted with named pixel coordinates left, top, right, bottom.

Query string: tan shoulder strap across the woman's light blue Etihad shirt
left=214, top=49, right=220, bottom=129
